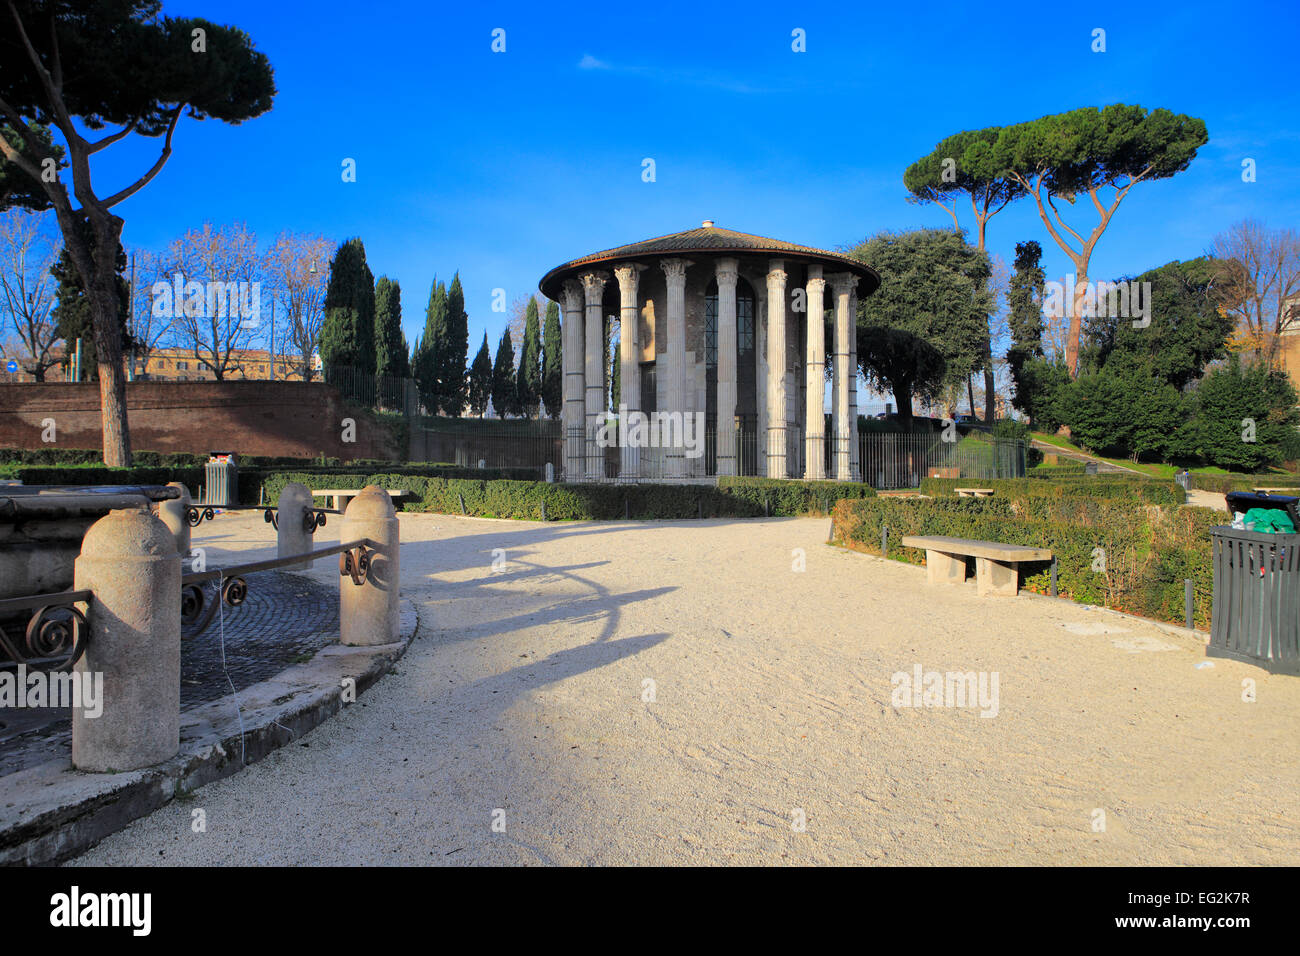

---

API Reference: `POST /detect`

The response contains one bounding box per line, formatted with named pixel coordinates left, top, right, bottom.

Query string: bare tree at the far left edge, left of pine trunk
left=0, top=209, right=60, bottom=381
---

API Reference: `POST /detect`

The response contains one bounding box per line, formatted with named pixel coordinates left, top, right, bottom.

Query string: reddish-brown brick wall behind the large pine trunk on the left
left=0, top=381, right=406, bottom=459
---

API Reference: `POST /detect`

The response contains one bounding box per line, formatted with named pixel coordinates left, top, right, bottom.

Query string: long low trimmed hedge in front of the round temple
left=264, top=472, right=875, bottom=520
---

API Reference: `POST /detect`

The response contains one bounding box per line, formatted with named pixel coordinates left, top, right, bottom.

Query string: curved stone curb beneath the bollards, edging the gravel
left=0, top=600, right=419, bottom=866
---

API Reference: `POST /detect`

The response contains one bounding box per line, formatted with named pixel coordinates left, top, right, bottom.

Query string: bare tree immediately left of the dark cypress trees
left=267, top=232, right=337, bottom=381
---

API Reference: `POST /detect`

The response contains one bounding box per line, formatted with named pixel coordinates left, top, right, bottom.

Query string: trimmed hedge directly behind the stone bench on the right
left=832, top=497, right=1225, bottom=628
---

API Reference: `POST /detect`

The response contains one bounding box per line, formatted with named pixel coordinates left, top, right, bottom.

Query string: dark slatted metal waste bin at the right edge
left=1206, top=520, right=1300, bottom=674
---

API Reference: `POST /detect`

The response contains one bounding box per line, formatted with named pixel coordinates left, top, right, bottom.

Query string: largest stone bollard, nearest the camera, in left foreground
left=73, top=509, right=181, bottom=773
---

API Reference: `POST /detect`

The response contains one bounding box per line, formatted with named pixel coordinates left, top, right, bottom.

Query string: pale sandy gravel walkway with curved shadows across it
left=68, top=515, right=1300, bottom=865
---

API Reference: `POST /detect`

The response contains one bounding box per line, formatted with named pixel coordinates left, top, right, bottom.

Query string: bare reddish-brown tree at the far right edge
left=1210, top=219, right=1300, bottom=368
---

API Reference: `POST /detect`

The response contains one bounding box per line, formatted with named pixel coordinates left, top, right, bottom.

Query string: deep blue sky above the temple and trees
left=96, top=0, right=1300, bottom=387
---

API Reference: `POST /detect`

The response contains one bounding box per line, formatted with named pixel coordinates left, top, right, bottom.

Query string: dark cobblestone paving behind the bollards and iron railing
left=0, top=571, right=338, bottom=775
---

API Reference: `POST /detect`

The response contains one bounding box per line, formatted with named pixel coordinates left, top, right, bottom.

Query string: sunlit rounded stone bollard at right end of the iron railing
left=338, top=485, right=402, bottom=646
